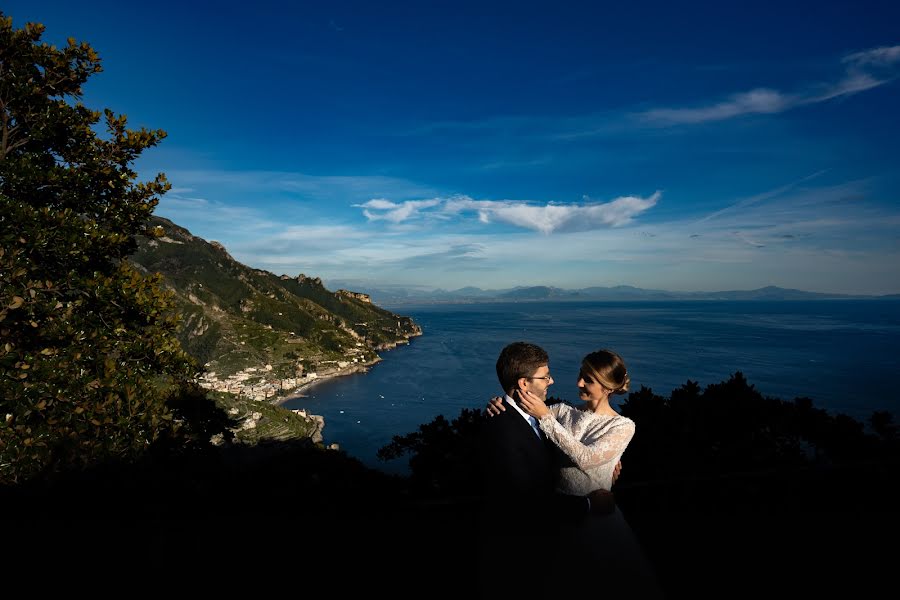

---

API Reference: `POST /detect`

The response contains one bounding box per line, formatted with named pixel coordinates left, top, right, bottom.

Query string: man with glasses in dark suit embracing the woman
left=479, top=342, right=615, bottom=598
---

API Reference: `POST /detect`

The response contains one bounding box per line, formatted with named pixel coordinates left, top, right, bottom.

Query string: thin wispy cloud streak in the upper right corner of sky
left=635, top=46, right=900, bottom=126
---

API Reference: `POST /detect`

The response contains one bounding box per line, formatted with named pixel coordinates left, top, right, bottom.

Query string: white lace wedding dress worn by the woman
left=538, top=403, right=663, bottom=598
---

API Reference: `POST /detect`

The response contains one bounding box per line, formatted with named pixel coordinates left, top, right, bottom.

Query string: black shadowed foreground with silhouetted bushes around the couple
left=0, top=374, right=900, bottom=598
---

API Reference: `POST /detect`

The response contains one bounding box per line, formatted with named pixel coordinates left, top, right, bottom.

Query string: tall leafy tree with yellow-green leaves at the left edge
left=0, top=13, right=213, bottom=483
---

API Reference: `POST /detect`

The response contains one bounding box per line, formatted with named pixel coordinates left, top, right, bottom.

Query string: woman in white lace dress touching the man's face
left=488, top=350, right=662, bottom=598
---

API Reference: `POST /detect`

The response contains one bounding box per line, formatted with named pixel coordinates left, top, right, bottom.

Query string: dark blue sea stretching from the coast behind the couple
left=282, top=300, right=900, bottom=475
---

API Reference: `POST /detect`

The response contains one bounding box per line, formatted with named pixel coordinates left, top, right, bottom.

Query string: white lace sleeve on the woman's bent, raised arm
left=538, top=412, right=634, bottom=470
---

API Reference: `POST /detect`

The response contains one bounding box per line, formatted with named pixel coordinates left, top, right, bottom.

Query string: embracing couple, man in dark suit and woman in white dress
left=479, top=342, right=662, bottom=598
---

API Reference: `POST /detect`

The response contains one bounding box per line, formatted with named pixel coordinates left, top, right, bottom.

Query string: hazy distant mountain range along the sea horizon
left=332, top=285, right=884, bottom=305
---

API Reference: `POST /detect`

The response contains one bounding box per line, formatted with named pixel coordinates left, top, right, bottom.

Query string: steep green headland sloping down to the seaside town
left=130, top=217, right=421, bottom=377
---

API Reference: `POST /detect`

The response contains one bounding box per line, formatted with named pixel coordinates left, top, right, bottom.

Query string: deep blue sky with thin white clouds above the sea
left=2, top=0, right=900, bottom=294
